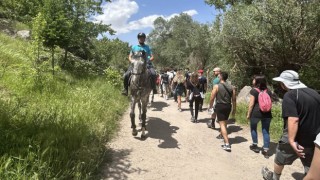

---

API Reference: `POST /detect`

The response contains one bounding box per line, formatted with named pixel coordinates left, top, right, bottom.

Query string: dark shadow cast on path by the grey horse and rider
left=147, top=117, right=179, bottom=148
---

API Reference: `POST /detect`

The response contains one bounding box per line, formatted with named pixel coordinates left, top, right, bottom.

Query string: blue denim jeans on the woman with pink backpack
left=250, top=118, right=271, bottom=149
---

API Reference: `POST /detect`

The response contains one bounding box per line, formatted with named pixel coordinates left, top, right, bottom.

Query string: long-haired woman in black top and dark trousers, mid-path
left=186, top=73, right=202, bottom=123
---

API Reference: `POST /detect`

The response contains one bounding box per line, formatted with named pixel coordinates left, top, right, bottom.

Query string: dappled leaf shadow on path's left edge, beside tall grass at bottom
left=101, top=149, right=147, bottom=179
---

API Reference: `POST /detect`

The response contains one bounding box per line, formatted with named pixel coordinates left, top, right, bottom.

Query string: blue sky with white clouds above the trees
left=93, top=0, right=217, bottom=45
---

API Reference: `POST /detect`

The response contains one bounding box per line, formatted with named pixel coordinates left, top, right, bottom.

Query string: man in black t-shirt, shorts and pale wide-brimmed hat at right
left=262, top=70, right=320, bottom=180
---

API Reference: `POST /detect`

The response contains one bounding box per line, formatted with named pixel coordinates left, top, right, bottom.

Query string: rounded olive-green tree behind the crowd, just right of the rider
left=148, top=13, right=210, bottom=70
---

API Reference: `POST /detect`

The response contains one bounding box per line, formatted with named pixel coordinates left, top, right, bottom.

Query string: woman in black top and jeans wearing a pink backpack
left=247, top=75, right=272, bottom=158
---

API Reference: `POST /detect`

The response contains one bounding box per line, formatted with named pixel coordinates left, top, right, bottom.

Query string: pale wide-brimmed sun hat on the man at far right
left=273, top=70, right=307, bottom=89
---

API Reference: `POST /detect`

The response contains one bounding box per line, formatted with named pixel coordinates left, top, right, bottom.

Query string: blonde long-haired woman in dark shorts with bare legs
left=171, top=69, right=186, bottom=112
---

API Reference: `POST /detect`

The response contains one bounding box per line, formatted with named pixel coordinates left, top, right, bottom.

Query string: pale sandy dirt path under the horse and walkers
left=103, top=95, right=303, bottom=180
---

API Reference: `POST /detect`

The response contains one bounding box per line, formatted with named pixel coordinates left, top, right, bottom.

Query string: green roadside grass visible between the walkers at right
left=205, top=93, right=283, bottom=142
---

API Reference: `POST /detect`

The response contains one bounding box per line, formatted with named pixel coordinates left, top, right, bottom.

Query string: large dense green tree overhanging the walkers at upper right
left=205, top=0, right=320, bottom=86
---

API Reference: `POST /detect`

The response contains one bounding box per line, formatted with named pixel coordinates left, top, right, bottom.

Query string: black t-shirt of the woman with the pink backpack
left=250, top=88, right=272, bottom=118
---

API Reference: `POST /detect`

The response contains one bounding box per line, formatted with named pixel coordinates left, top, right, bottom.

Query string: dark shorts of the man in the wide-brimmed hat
left=274, top=141, right=314, bottom=173
